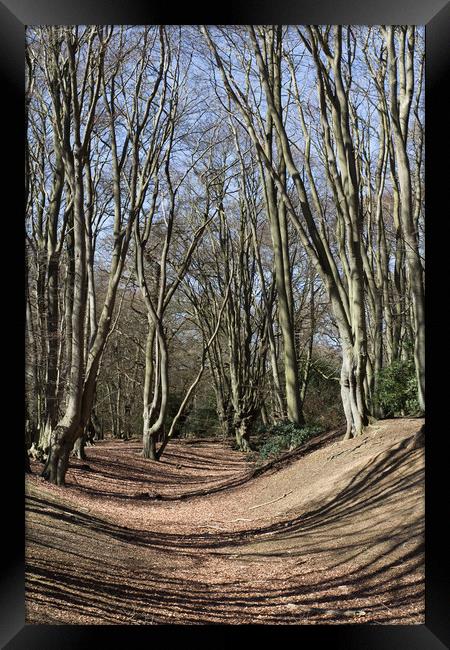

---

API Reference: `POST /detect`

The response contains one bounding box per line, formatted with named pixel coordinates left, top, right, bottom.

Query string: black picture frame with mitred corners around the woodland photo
left=0, top=0, right=450, bottom=650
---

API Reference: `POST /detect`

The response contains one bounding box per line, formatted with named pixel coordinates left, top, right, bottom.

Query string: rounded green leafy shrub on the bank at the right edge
left=376, top=359, right=420, bottom=417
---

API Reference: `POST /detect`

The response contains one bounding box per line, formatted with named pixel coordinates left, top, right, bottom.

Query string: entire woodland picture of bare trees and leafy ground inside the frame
left=24, top=25, right=425, bottom=625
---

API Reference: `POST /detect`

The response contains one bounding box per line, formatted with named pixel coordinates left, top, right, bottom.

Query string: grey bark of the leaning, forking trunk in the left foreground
left=45, top=28, right=165, bottom=484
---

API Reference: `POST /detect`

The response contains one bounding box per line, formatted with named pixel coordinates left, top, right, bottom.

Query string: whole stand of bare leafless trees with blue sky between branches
left=25, top=25, right=424, bottom=482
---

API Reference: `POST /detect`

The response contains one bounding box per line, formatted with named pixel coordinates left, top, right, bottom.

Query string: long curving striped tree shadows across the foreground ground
left=26, top=436, right=424, bottom=625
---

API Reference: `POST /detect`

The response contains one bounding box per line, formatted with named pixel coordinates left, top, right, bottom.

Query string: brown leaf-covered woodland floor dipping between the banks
left=26, top=419, right=424, bottom=625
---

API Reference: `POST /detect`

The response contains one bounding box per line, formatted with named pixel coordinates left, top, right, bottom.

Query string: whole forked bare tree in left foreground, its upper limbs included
left=30, top=27, right=169, bottom=484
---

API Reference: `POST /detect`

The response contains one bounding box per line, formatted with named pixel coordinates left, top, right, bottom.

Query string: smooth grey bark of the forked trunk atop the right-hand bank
left=239, top=27, right=367, bottom=435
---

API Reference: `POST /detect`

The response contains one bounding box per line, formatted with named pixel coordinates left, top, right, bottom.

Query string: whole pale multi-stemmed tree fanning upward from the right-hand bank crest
left=202, top=26, right=421, bottom=437
